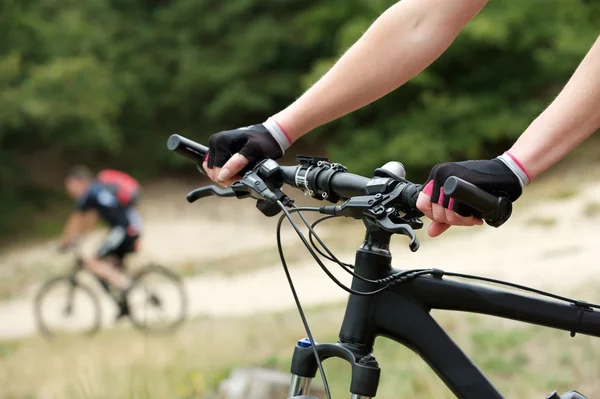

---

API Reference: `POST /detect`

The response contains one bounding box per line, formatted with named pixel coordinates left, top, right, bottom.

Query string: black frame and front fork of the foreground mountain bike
left=290, top=222, right=600, bottom=399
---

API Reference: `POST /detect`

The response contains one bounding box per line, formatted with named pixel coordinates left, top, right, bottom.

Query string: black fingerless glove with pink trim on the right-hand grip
left=423, top=153, right=529, bottom=217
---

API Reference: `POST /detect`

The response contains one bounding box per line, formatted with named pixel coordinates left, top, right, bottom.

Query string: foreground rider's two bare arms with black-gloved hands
left=203, top=0, right=600, bottom=237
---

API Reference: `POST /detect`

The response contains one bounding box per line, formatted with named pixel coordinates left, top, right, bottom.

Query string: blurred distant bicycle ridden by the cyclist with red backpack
left=34, top=249, right=187, bottom=338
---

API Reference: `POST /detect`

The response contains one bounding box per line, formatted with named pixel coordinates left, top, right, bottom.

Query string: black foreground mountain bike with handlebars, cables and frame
left=167, top=135, right=600, bottom=399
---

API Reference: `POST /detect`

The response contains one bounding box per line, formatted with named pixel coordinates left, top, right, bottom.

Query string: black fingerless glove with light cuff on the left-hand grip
left=207, top=118, right=290, bottom=169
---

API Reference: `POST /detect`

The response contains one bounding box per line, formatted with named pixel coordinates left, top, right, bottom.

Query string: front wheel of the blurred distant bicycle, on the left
left=35, top=276, right=101, bottom=338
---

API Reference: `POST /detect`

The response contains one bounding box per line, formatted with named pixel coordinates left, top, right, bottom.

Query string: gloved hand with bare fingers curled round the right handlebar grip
left=417, top=153, right=529, bottom=237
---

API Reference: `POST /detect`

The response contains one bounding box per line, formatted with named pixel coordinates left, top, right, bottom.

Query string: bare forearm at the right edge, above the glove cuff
left=510, top=37, right=600, bottom=178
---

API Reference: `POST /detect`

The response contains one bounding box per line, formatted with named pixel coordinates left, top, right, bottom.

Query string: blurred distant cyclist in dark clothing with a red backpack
left=60, top=165, right=141, bottom=318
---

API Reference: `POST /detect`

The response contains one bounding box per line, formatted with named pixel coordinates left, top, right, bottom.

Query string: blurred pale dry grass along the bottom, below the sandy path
left=0, top=306, right=600, bottom=399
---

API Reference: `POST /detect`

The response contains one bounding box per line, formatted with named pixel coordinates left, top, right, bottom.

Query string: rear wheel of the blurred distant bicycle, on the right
left=127, top=265, right=187, bottom=333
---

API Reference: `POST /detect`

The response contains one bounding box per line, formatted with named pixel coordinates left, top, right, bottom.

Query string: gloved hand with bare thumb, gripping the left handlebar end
left=202, top=118, right=291, bottom=186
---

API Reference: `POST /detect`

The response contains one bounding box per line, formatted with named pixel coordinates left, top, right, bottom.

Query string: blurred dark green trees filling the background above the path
left=0, top=0, right=600, bottom=235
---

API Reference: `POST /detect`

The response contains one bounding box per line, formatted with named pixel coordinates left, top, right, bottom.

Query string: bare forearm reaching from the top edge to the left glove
left=274, top=0, right=487, bottom=140
